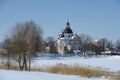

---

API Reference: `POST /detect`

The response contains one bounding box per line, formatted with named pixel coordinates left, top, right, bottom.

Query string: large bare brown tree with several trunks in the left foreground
left=4, top=21, right=42, bottom=71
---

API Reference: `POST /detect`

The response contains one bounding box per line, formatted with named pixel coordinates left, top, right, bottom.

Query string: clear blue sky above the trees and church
left=0, top=0, right=120, bottom=42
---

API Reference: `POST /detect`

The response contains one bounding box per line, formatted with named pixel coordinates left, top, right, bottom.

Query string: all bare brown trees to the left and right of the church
left=0, top=21, right=120, bottom=71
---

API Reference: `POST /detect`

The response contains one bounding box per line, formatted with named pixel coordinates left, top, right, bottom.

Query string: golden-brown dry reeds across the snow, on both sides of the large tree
left=0, top=64, right=120, bottom=80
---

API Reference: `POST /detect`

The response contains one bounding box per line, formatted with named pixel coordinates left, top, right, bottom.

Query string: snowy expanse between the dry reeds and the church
left=32, top=56, right=120, bottom=72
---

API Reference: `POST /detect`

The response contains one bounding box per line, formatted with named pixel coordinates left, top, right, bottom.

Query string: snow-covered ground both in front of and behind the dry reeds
left=0, top=56, right=120, bottom=80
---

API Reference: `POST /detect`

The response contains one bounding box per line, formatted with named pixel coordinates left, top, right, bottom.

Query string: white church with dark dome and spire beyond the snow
left=56, top=21, right=81, bottom=54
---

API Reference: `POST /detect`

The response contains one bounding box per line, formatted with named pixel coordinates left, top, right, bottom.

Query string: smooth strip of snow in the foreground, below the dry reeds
left=0, top=70, right=106, bottom=80
